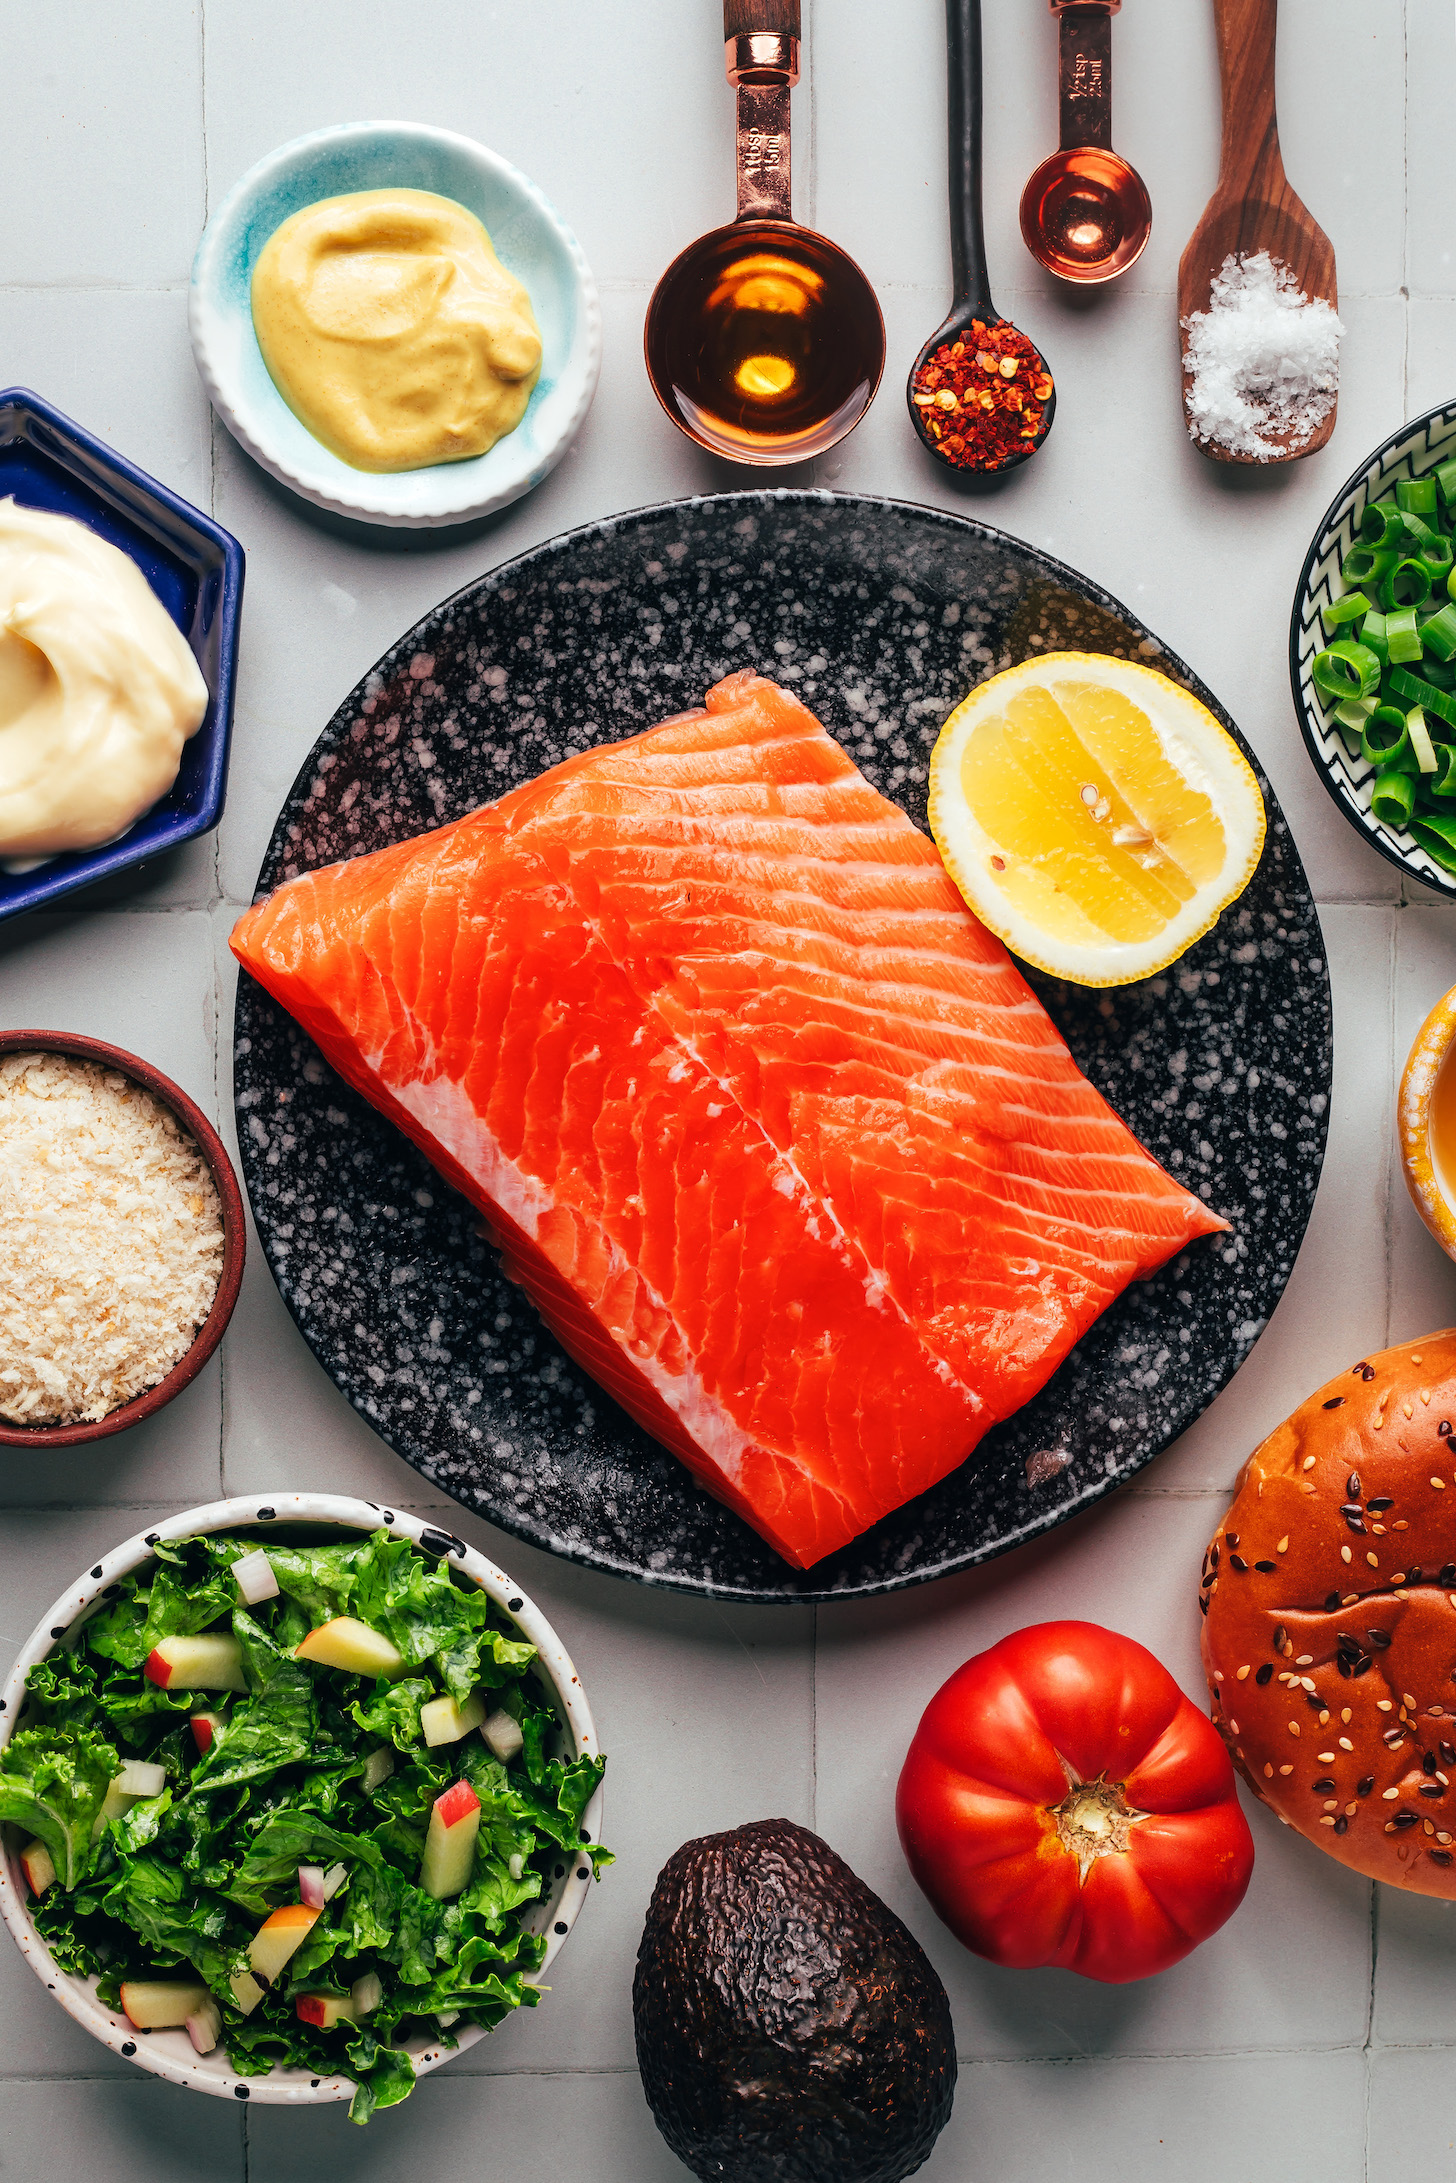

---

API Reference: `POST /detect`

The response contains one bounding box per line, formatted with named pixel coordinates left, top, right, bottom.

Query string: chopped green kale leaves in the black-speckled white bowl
left=0, top=1528, right=611, bottom=2122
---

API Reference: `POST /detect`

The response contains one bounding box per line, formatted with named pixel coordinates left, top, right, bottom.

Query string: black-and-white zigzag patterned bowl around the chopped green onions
left=1290, top=402, right=1456, bottom=897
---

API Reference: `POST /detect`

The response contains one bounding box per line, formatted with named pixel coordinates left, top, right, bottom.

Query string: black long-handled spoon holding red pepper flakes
left=906, top=0, right=1057, bottom=478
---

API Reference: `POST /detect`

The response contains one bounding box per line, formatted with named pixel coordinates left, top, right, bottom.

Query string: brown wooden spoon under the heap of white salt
left=1179, top=0, right=1338, bottom=469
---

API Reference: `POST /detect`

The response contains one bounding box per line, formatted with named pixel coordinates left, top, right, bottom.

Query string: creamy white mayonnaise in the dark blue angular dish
left=0, top=500, right=207, bottom=858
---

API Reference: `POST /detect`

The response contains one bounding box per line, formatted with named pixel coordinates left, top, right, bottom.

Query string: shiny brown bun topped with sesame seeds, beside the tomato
left=1198, top=1329, right=1456, bottom=1899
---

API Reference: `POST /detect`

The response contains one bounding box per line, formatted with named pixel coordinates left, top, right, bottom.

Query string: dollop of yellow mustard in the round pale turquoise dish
left=253, top=190, right=541, bottom=469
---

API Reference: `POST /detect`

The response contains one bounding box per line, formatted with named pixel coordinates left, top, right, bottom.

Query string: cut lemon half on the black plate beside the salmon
left=930, top=653, right=1264, bottom=985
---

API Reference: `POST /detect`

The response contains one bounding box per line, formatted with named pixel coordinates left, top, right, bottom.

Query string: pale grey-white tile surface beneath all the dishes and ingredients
left=0, top=0, right=1456, bottom=2183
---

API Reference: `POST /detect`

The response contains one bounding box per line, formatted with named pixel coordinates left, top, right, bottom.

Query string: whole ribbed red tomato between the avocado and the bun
left=895, top=1622, right=1253, bottom=1984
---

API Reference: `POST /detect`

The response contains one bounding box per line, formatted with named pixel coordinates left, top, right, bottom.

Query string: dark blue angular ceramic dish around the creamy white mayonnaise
left=0, top=386, right=244, bottom=919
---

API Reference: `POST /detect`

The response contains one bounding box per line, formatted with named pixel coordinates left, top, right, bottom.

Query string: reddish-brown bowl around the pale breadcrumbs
left=0, top=1030, right=247, bottom=1450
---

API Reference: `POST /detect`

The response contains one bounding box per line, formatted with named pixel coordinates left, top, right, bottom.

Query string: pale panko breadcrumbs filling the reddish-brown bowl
left=0, top=1054, right=223, bottom=1425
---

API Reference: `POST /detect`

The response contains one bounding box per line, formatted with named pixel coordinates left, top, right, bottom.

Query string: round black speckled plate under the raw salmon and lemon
left=236, top=491, right=1329, bottom=1600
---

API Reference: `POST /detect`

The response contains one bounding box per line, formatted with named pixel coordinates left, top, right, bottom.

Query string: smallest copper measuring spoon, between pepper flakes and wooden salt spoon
left=1022, top=0, right=1153, bottom=284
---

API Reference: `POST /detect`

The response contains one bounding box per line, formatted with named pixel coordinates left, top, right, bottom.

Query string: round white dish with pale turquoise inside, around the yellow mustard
left=188, top=122, right=602, bottom=530
